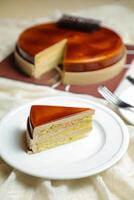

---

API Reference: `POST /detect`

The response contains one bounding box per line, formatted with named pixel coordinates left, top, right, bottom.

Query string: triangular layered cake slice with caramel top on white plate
left=26, top=105, right=94, bottom=153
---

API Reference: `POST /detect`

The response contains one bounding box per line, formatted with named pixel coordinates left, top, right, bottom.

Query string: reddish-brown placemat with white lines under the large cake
left=0, top=45, right=134, bottom=97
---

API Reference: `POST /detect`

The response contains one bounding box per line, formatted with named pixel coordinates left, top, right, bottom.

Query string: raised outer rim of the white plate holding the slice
left=0, top=95, right=129, bottom=180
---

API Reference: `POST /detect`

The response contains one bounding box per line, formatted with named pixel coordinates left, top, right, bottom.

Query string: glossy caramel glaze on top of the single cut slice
left=29, top=105, right=94, bottom=128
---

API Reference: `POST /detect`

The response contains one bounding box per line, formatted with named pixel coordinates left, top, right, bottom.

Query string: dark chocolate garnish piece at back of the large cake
left=58, top=15, right=101, bottom=32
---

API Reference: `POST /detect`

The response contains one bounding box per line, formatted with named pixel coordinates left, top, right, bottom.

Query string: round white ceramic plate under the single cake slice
left=0, top=96, right=129, bottom=179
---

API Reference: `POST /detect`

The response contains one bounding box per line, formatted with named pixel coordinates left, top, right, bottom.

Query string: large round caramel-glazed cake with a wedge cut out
left=15, top=15, right=126, bottom=85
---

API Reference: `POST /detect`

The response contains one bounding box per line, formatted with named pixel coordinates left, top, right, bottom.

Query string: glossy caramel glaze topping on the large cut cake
left=17, top=23, right=125, bottom=72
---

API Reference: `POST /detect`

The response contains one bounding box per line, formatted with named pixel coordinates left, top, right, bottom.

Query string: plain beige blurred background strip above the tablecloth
left=0, top=0, right=134, bottom=19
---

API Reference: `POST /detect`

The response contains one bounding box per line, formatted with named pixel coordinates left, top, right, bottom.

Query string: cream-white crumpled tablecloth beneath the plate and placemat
left=0, top=4, right=134, bottom=200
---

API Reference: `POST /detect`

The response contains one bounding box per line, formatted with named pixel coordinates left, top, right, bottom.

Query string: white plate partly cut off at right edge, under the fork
left=119, top=87, right=134, bottom=125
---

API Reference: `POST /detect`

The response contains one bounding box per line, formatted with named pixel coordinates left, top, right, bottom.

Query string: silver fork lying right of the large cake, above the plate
left=98, top=85, right=134, bottom=112
